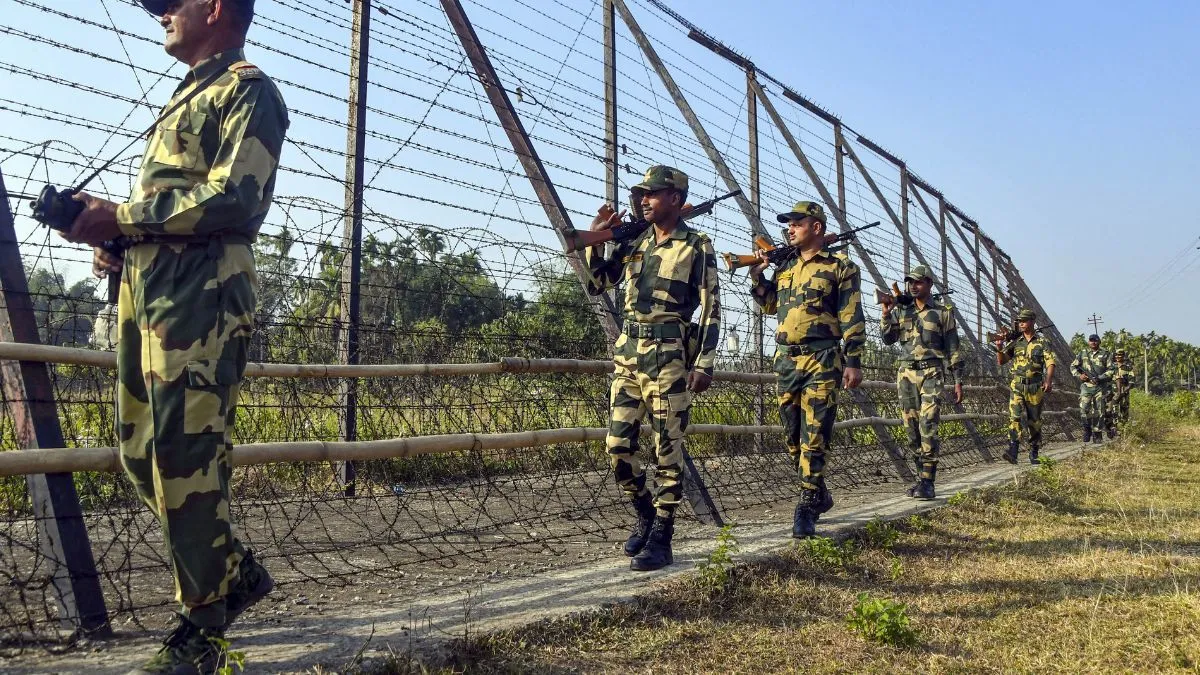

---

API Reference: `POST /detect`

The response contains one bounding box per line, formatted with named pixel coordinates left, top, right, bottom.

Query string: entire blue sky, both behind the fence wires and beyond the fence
left=0, top=0, right=1200, bottom=344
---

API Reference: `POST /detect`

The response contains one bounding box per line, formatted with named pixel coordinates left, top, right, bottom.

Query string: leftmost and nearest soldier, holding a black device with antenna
left=67, top=0, right=288, bottom=674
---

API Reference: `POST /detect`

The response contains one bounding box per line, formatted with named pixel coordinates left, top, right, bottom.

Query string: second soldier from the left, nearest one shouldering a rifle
left=583, top=166, right=721, bottom=572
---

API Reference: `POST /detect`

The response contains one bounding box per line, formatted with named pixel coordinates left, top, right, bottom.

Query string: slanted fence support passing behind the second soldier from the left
left=442, top=0, right=724, bottom=525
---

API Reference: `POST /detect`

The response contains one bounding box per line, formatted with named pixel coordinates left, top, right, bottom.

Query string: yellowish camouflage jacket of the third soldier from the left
left=751, top=243, right=866, bottom=368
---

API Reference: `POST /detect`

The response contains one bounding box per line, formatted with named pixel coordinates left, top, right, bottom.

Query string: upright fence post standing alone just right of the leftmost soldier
left=336, top=0, right=371, bottom=497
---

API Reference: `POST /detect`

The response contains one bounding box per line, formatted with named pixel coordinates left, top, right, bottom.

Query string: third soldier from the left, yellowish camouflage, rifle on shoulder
left=750, top=196, right=866, bottom=538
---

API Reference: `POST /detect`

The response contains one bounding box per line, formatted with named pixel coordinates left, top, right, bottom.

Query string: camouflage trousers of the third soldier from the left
left=773, top=346, right=842, bottom=490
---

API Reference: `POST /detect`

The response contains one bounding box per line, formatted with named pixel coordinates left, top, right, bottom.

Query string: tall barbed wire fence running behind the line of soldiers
left=0, top=0, right=1073, bottom=650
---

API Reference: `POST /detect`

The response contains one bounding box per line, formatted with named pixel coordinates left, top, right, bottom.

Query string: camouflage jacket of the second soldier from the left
left=583, top=221, right=721, bottom=375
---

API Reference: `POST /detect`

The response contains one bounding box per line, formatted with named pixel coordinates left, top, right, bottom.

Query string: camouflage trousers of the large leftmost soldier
left=116, top=243, right=258, bottom=627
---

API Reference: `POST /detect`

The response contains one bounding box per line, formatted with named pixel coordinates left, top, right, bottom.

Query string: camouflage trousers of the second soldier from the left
left=605, top=335, right=691, bottom=518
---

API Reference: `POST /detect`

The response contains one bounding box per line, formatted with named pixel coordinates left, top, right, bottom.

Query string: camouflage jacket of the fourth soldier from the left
left=880, top=296, right=962, bottom=384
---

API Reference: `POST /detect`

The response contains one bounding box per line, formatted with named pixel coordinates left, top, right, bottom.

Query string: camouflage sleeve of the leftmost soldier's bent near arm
left=116, top=78, right=288, bottom=237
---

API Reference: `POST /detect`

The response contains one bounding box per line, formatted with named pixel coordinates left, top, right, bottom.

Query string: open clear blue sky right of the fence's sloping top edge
left=676, top=0, right=1200, bottom=345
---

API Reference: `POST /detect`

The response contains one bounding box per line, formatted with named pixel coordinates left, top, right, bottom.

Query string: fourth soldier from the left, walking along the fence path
left=880, top=265, right=962, bottom=500
